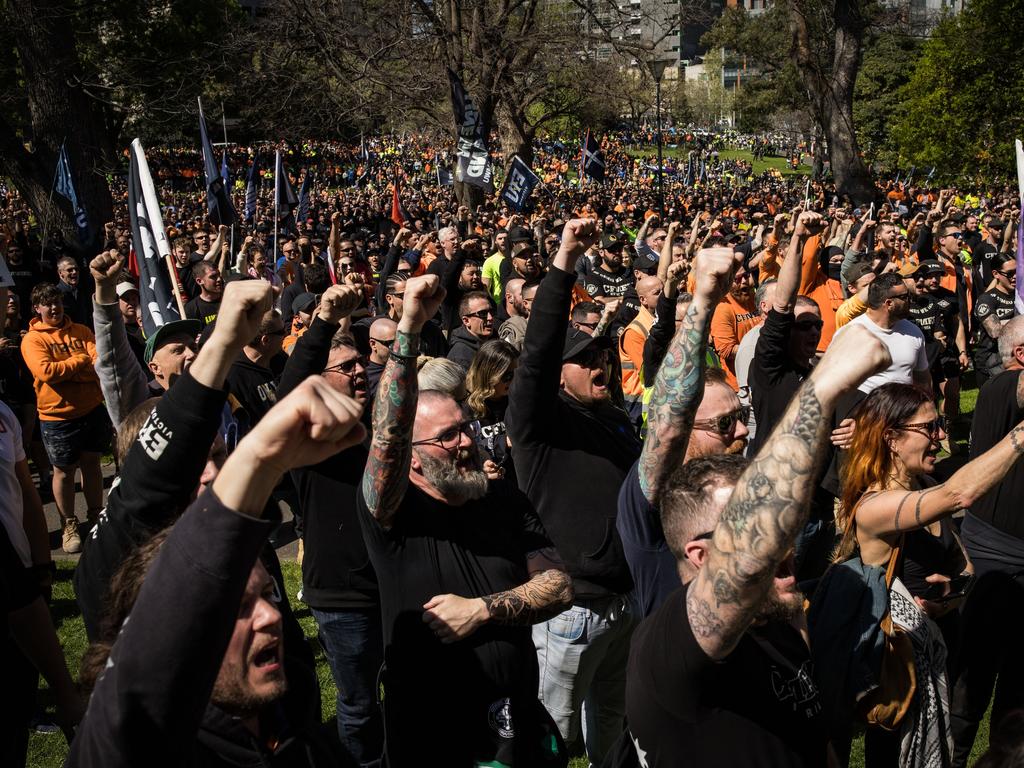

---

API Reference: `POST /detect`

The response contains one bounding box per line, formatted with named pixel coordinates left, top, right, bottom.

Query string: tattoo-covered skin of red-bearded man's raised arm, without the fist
left=639, top=301, right=711, bottom=504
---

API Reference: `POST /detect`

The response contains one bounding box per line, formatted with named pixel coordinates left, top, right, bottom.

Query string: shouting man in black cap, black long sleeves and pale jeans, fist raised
left=505, top=219, right=640, bottom=765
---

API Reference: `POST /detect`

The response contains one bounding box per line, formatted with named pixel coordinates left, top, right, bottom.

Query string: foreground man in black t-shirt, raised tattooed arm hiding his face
left=627, top=328, right=890, bottom=768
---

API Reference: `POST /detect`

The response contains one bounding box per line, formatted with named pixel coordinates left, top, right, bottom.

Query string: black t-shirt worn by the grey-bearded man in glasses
left=357, top=481, right=552, bottom=766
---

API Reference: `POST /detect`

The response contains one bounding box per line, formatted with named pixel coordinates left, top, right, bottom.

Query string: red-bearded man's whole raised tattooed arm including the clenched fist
left=639, top=248, right=741, bottom=504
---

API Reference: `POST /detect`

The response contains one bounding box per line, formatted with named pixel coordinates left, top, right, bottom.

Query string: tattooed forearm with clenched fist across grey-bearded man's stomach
left=423, top=547, right=573, bottom=643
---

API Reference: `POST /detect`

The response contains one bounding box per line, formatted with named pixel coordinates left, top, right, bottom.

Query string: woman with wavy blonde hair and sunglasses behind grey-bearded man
left=466, top=339, right=519, bottom=481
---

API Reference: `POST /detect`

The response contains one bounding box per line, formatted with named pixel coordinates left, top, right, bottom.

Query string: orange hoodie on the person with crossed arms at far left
left=22, top=316, right=103, bottom=421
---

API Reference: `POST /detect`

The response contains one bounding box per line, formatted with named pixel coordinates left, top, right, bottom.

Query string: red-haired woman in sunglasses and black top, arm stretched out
left=835, top=384, right=1024, bottom=768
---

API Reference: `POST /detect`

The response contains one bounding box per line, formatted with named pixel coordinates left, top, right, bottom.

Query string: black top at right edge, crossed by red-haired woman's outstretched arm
left=971, top=371, right=1024, bottom=540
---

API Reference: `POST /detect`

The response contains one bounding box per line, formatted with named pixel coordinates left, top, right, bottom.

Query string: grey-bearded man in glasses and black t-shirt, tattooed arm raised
left=357, top=275, right=572, bottom=768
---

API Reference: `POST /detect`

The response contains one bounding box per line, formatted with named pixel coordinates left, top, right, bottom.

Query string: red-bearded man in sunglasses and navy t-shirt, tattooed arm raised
left=616, top=248, right=746, bottom=616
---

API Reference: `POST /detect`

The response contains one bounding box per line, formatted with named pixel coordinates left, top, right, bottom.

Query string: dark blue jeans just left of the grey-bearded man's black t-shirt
left=310, top=608, right=384, bottom=768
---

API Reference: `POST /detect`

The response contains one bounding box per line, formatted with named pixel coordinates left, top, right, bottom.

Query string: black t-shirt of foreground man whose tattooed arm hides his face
left=626, top=587, right=827, bottom=768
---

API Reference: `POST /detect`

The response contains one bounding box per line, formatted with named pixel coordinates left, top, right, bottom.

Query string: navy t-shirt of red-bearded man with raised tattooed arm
left=615, top=460, right=679, bottom=616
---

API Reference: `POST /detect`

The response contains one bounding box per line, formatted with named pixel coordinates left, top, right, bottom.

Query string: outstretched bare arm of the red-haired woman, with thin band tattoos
left=857, top=422, right=1024, bottom=537
